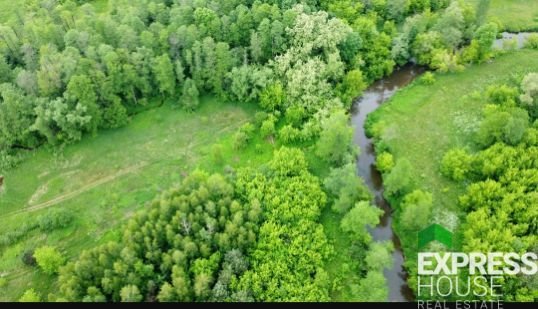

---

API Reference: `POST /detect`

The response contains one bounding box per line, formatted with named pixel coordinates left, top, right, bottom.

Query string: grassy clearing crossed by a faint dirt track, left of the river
left=0, top=97, right=273, bottom=301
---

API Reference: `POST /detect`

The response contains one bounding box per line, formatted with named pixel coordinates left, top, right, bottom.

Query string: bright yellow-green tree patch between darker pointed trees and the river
left=234, top=148, right=332, bottom=301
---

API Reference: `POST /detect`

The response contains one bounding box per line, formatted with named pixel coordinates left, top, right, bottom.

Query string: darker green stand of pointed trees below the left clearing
left=59, top=171, right=261, bottom=301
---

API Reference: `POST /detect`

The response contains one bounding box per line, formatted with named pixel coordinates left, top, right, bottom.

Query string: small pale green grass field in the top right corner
left=470, top=0, right=538, bottom=32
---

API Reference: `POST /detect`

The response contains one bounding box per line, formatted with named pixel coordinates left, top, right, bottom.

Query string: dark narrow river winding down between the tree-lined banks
left=351, top=65, right=424, bottom=301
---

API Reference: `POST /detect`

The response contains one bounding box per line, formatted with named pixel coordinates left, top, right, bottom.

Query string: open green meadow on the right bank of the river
left=370, top=50, right=538, bottom=276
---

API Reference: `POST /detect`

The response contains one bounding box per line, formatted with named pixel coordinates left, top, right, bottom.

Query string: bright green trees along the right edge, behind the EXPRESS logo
left=441, top=73, right=538, bottom=302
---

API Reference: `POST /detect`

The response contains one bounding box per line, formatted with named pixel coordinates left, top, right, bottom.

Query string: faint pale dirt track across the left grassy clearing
left=0, top=162, right=148, bottom=218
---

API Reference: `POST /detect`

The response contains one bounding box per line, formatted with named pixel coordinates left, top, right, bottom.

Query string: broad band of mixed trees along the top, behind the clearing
left=0, top=0, right=492, bottom=168
